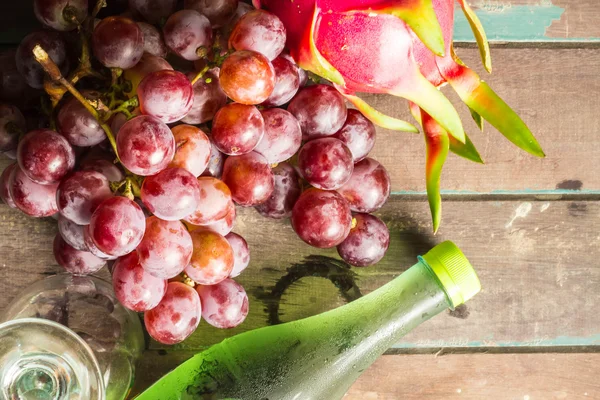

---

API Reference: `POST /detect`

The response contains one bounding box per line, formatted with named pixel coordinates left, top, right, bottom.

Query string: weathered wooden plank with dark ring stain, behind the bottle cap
left=0, top=197, right=600, bottom=349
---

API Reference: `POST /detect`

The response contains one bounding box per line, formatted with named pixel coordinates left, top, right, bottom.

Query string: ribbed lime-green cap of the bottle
left=423, top=241, right=481, bottom=307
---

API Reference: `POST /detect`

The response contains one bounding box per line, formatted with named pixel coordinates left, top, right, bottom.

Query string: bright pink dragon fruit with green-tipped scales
left=254, top=0, right=544, bottom=231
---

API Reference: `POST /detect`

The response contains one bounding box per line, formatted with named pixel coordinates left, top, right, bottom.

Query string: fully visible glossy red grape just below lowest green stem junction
left=89, top=196, right=146, bottom=257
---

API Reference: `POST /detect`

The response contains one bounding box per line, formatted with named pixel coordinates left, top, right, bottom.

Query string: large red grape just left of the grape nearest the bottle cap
left=292, top=188, right=352, bottom=248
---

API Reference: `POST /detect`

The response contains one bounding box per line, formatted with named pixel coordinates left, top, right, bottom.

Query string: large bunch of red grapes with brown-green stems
left=0, top=0, right=390, bottom=344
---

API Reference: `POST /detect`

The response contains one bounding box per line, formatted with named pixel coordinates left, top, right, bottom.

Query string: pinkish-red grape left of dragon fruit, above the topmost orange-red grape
left=229, top=10, right=286, bottom=60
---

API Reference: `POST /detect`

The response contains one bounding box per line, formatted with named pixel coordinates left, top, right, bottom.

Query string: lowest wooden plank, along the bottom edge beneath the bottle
left=132, top=351, right=600, bottom=400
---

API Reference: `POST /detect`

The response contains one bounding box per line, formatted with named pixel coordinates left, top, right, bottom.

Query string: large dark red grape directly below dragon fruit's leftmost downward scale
left=288, top=84, right=347, bottom=140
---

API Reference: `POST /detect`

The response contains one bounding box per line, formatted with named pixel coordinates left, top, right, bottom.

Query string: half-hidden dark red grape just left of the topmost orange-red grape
left=181, top=68, right=227, bottom=125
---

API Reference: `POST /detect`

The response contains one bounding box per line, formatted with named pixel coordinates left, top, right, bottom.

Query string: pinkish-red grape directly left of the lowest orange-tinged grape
left=137, top=217, right=194, bottom=279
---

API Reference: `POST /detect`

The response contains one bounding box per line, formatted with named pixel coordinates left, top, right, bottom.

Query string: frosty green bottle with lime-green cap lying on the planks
left=137, top=242, right=481, bottom=400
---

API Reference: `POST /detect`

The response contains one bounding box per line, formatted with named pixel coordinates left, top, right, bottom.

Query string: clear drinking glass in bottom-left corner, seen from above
left=0, top=274, right=144, bottom=400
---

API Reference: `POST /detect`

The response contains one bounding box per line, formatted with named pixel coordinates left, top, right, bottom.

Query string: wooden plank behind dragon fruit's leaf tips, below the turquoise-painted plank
left=0, top=49, right=600, bottom=194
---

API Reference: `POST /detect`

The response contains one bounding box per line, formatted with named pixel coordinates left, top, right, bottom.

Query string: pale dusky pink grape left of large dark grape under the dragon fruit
left=254, top=108, right=302, bottom=164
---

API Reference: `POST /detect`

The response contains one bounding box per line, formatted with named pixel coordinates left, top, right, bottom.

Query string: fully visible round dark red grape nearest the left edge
left=17, top=129, right=75, bottom=185
